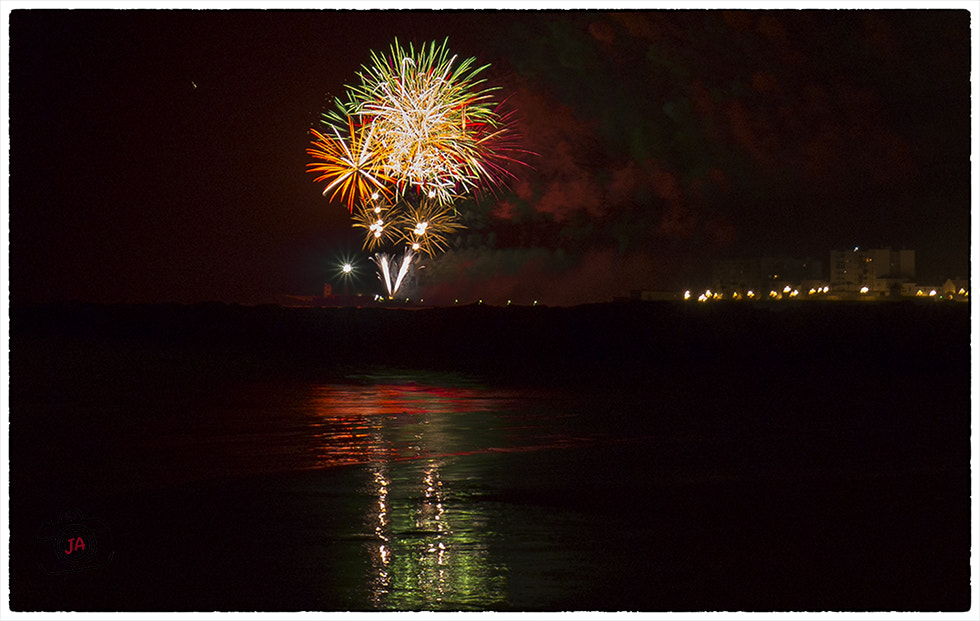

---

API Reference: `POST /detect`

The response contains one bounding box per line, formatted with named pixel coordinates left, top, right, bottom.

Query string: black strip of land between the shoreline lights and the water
left=10, top=301, right=970, bottom=392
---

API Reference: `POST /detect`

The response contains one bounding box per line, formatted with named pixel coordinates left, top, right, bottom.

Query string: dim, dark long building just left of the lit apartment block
left=711, top=256, right=823, bottom=295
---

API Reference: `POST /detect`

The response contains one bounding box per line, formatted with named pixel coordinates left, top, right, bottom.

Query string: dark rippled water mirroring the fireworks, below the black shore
left=10, top=300, right=970, bottom=611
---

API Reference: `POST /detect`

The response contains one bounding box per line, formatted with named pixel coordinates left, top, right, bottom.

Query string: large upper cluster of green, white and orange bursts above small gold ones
left=308, top=40, right=513, bottom=211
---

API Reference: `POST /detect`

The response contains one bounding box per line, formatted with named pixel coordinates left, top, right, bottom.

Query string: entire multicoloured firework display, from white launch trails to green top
left=307, top=40, right=522, bottom=296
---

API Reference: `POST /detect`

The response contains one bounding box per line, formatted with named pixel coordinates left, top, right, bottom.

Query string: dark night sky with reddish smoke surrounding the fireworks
left=8, top=4, right=975, bottom=304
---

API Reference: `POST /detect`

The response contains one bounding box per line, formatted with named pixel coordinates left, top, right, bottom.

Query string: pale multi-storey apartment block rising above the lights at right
left=830, top=246, right=915, bottom=293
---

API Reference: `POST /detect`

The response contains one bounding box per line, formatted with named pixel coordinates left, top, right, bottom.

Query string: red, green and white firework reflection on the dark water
left=312, top=376, right=511, bottom=610
